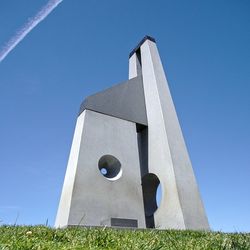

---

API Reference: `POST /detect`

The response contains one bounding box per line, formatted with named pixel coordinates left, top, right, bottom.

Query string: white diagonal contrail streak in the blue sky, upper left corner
left=0, top=0, right=63, bottom=62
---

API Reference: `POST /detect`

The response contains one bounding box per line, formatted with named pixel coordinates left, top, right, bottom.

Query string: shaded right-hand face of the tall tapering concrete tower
left=142, top=41, right=209, bottom=229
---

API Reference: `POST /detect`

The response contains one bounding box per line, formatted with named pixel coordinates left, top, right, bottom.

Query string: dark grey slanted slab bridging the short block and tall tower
left=80, top=76, right=147, bottom=125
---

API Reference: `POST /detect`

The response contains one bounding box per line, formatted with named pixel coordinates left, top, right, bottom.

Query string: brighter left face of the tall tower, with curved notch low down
left=140, top=40, right=185, bottom=229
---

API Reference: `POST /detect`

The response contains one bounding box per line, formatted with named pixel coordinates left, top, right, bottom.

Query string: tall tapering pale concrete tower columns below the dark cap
left=129, top=40, right=209, bottom=229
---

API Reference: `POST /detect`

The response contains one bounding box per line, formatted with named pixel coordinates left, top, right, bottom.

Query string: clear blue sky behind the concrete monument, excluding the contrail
left=0, top=0, right=250, bottom=232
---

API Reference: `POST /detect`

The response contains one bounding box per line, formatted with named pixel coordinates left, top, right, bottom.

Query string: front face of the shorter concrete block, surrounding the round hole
left=56, top=110, right=145, bottom=228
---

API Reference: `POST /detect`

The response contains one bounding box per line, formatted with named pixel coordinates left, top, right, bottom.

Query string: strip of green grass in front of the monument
left=0, top=226, right=250, bottom=250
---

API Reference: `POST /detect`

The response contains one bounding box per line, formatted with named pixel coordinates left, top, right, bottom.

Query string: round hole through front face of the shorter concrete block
left=98, top=155, right=122, bottom=181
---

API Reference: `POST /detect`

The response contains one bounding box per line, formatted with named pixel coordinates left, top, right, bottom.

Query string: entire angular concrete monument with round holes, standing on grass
left=55, top=36, right=209, bottom=230
